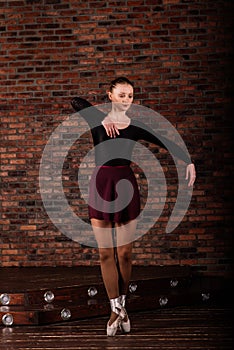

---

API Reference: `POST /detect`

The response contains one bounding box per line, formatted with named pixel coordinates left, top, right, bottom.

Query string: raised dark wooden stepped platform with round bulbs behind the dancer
left=0, top=266, right=230, bottom=326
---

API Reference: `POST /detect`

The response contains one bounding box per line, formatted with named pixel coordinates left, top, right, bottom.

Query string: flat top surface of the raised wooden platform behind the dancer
left=0, top=265, right=191, bottom=293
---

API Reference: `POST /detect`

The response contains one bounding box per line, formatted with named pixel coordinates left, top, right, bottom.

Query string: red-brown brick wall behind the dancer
left=0, top=0, right=233, bottom=274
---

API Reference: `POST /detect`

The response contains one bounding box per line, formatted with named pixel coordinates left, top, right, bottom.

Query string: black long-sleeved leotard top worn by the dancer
left=72, top=98, right=191, bottom=166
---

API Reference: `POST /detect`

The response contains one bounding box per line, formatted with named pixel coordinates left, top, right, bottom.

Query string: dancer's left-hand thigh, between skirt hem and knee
left=91, top=219, right=114, bottom=248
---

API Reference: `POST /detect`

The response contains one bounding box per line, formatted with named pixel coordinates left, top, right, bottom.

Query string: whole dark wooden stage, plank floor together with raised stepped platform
left=0, top=266, right=234, bottom=350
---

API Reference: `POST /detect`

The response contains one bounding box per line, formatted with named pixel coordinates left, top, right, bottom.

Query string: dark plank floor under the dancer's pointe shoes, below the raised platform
left=0, top=305, right=233, bottom=350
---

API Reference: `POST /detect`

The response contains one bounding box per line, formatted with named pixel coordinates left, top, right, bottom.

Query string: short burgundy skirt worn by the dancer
left=88, top=166, right=140, bottom=223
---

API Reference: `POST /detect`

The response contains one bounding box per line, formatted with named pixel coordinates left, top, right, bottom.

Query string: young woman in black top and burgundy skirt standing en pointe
left=71, top=77, right=196, bottom=336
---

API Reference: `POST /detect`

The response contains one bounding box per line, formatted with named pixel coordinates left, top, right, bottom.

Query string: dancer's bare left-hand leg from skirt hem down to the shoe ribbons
left=91, top=219, right=119, bottom=325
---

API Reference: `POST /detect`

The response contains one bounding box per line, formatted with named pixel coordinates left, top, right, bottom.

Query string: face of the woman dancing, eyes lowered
left=108, top=84, right=133, bottom=111
